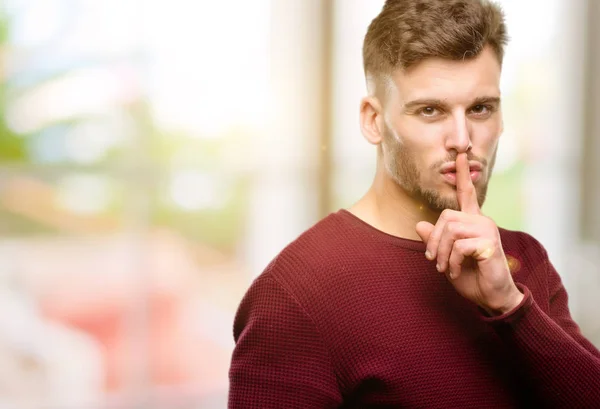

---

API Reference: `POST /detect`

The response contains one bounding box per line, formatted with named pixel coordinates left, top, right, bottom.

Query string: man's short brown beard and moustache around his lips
left=382, top=126, right=497, bottom=212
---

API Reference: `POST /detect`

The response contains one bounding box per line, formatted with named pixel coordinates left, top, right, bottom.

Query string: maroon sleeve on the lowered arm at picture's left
left=228, top=274, right=342, bottom=409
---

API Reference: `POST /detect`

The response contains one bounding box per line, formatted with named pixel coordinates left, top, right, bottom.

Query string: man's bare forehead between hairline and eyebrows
left=391, top=47, right=501, bottom=104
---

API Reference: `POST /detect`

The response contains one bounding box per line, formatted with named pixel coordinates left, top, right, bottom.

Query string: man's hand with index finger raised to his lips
left=417, top=153, right=523, bottom=315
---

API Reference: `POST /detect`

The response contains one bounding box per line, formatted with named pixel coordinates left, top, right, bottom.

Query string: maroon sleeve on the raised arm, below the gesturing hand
left=483, top=250, right=600, bottom=408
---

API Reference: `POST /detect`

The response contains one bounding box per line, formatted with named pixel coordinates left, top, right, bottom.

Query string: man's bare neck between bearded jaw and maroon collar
left=348, top=166, right=440, bottom=241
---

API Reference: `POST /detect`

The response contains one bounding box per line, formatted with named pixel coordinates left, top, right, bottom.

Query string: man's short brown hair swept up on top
left=363, top=0, right=508, bottom=88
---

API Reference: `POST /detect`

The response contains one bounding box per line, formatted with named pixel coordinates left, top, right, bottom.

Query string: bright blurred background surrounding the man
left=0, top=0, right=600, bottom=409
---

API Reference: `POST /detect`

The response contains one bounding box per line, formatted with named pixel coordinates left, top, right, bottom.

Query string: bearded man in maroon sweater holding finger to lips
left=229, top=0, right=600, bottom=409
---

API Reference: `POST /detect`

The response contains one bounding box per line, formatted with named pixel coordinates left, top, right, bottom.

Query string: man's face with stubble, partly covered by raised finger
left=382, top=47, right=502, bottom=211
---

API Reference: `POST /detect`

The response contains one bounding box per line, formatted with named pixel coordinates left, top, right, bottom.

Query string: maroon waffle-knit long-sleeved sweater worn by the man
left=229, top=210, right=600, bottom=409
